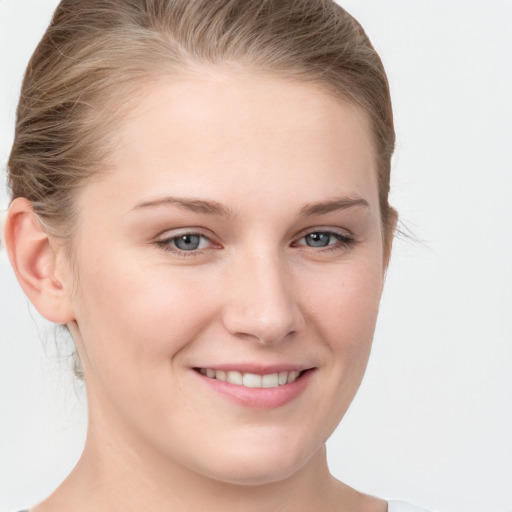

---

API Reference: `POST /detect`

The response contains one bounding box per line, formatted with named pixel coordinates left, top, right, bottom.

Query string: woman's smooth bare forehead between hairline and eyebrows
left=86, top=71, right=377, bottom=212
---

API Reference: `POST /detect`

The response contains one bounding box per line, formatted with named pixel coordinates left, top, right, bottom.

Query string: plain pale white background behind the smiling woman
left=0, top=0, right=512, bottom=512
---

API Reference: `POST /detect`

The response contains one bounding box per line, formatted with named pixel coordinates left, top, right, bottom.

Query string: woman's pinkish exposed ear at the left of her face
left=4, top=197, right=74, bottom=324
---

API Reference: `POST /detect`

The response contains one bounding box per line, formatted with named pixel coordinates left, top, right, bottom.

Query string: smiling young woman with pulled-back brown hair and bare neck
left=5, top=0, right=432, bottom=512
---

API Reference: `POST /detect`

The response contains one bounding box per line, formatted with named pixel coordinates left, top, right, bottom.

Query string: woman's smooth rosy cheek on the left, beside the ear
left=70, top=245, right=214, bottom=379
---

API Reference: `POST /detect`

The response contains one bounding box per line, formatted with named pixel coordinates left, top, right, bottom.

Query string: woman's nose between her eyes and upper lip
left=223, top=247, right=304, bottom=345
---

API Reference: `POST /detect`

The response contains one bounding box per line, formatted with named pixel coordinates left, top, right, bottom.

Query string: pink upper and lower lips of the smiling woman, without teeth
left=193, top=364, right=315, bottom=409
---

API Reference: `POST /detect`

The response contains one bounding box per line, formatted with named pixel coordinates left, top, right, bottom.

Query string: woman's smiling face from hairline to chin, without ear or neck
left=64, top=71, right=385, bottom=484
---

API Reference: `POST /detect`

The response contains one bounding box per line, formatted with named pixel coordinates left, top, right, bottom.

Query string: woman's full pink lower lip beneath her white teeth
left=194, top=370, right=314, bottom=409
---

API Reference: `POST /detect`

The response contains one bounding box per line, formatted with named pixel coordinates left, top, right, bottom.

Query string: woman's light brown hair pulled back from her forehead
left=8, top=0, right=395, bottom=243
